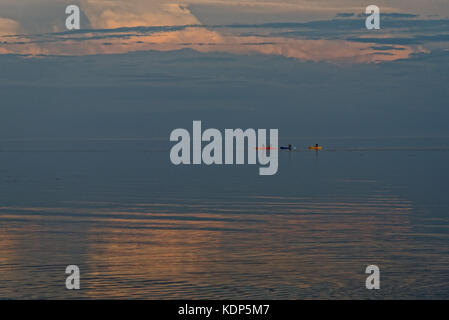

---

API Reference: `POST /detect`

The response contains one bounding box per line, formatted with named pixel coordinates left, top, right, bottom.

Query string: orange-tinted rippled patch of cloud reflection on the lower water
left=0, top=195, right=444, bottom=299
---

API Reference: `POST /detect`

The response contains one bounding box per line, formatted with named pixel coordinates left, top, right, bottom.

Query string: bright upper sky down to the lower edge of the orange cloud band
left=0, top=0, right=449, bottom=63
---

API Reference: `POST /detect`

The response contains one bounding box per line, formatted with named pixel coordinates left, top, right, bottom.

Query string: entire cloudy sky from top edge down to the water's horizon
left=0, top=0, right=449, bottom=139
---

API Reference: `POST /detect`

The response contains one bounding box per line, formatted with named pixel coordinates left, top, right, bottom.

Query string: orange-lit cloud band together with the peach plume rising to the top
left=0, top=5, right=449, bottom=63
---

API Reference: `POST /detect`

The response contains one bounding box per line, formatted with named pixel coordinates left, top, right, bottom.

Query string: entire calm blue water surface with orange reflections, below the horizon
left=0, top=142, right=449, bottom=299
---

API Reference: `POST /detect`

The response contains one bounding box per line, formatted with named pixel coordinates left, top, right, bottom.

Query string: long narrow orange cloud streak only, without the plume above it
left=0, top=27, right=419, bottom=63
